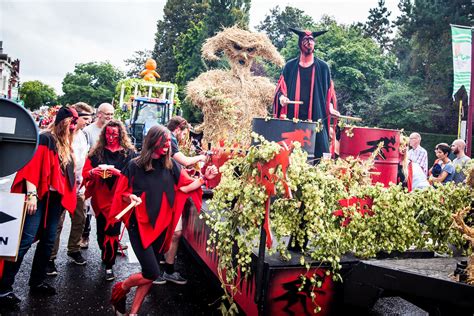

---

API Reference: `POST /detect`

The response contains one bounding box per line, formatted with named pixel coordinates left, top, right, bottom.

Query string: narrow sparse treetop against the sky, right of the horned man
left=363, top=0, right=393, bottom=51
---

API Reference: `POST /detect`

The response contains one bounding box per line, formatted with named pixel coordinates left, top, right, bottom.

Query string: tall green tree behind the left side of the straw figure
left=152, top=0, right=250, bottom=122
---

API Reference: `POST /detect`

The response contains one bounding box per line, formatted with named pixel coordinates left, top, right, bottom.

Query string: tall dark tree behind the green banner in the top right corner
left=393, top=0, right=472, bottom=133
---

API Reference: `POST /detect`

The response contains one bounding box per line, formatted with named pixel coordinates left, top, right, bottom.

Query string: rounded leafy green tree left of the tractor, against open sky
left=61, top=62, right=124, bottom=106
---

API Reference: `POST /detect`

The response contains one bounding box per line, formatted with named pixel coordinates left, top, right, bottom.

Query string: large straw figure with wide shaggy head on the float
left=187, top=26, right=284, bottom=145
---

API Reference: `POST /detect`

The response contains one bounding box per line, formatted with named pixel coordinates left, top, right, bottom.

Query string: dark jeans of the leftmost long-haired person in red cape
left=0, top=191, right=62, bottom=294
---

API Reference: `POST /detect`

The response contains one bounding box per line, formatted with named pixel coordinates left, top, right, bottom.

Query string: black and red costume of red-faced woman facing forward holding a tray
left=82, top=148, right=136, bottom=269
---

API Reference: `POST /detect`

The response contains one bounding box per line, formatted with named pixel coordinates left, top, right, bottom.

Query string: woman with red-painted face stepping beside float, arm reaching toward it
left=111, top=125, right=217, bottom=314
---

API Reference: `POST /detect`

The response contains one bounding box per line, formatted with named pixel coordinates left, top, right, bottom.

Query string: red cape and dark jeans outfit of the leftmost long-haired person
left=0, top=132, right=77, bottom=294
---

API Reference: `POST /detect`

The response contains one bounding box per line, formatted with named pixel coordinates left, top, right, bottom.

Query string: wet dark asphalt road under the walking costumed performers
left=0, top=178, right=222, bottom=316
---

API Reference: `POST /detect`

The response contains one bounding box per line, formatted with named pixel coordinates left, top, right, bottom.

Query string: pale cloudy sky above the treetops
left=0, top=0, right=399, bottom=94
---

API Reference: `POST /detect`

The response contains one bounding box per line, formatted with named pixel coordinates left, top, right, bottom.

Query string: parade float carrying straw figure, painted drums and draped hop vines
left=178, top=28, right=474, bottom=315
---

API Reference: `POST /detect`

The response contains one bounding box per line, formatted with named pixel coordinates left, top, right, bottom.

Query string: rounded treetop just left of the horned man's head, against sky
left=257, top=6, right=314, bottom=50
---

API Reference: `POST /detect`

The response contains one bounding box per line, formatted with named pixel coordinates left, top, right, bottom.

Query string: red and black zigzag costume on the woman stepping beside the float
left=111, top=158, right=202, bottom=280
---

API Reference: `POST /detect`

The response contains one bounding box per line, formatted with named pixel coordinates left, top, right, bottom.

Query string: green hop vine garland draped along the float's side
left=205, top=135, right=474, bottom=312
